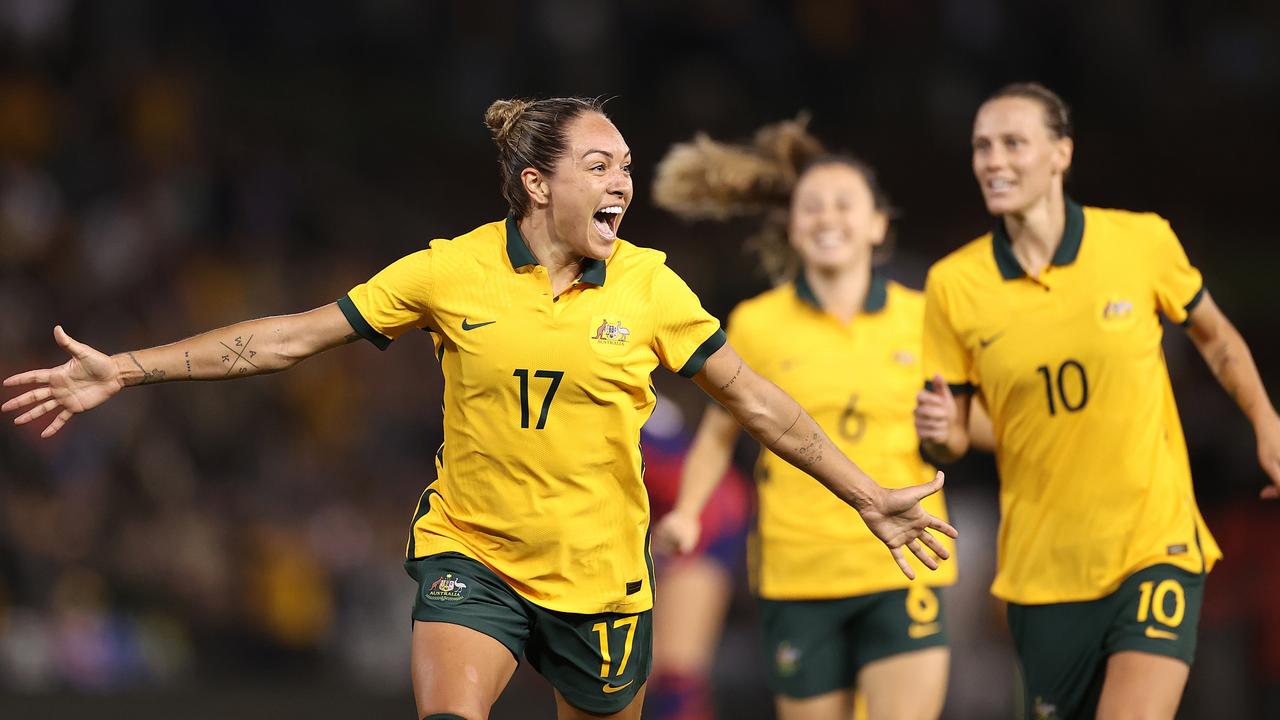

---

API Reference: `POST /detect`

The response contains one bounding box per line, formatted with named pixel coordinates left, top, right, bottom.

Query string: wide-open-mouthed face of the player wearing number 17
left=535, top=113, right=634, bottom=260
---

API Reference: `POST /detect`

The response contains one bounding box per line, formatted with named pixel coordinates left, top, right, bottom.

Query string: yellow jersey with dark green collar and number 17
left=339, top=219, right=724, bottom=614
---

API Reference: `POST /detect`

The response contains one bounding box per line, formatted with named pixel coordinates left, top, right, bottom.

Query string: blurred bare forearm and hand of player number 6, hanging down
left=653, top=405, right=740, bottom=555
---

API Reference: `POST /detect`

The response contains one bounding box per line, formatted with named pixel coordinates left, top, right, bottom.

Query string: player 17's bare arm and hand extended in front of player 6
left=694, top=345, right=956, bottom=579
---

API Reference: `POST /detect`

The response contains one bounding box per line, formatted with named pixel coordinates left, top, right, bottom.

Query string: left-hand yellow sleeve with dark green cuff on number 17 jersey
left=338, top=250, right=431, bottom=350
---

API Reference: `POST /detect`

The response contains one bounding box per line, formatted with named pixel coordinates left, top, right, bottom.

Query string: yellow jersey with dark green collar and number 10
left=924, top=201, right=1221, bottom=603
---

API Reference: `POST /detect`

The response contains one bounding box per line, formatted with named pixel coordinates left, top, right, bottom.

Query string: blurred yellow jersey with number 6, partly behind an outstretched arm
left=728, top=273, right=956, bottom=600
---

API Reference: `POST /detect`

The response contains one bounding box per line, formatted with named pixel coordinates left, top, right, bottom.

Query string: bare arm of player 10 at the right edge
left=1187, top=291, right=1280, bottom=491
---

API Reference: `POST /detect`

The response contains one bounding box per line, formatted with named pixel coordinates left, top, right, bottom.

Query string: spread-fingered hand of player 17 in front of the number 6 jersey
left=861, top=470, right=960, bottom=580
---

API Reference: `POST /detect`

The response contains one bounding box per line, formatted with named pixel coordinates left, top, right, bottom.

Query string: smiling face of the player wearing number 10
left=973, top=97, right=1073, bottom=215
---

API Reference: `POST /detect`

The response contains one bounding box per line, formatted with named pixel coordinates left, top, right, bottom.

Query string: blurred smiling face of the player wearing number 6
left=790, top=163, right=888, bottom=272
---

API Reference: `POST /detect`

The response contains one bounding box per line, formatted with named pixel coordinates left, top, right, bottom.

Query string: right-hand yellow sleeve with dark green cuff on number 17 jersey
left=653, top=264, right=724, bottom=378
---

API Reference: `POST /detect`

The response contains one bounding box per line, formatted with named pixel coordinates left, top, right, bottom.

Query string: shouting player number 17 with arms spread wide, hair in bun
left=3, top=99, right=955, bottom=720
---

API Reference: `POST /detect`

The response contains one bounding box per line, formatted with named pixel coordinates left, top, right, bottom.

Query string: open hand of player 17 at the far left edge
left=0, top=325, right=124, bottom=437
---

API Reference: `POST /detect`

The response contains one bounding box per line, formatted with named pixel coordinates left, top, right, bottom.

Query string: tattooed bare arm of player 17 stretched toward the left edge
left=0, top=302, right=360, bottom=437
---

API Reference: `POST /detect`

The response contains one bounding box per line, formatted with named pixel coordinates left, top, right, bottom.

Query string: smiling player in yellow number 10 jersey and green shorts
left=915, top=83, right=1280, bottom=719
